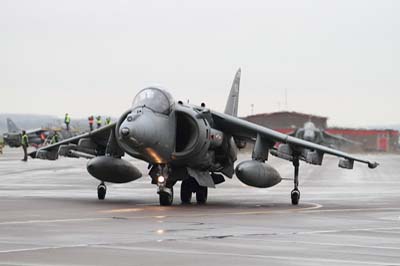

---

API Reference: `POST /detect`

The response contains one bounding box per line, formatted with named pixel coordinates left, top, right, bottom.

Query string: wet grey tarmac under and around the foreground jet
left=0, top=148, right=400, bottom=266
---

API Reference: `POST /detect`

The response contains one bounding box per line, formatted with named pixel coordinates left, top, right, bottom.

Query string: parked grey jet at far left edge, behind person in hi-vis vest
left=3, top=118, right=49, bottom=148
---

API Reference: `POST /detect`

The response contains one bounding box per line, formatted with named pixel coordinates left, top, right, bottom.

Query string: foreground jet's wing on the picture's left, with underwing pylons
left=29, top=123, right=116, bottom=160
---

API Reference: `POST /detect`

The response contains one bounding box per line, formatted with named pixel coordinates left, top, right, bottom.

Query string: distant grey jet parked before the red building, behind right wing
left=288, top=121, right=362, bottom=149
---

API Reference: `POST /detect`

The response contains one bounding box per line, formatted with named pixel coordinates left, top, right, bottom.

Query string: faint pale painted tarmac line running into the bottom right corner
left=90, top=245, right=400, bottom=265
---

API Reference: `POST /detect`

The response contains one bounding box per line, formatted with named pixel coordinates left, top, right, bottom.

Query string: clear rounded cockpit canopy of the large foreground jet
left=132, top=87, right=174, bottom=115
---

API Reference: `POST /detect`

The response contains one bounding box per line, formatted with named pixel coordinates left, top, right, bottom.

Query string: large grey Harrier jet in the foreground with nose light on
left=30, top=69, right=378, bottom=205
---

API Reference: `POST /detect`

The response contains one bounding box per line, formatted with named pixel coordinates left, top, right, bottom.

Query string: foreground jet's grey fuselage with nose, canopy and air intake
left=116, top=87, right=234, bottom=170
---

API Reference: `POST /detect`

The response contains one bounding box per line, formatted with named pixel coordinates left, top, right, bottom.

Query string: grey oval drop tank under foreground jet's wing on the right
left=235, top=160, right=282, bottom=188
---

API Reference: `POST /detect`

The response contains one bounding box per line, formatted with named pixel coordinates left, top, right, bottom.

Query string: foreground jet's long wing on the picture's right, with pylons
left=211, top=111, right=378, bottom=169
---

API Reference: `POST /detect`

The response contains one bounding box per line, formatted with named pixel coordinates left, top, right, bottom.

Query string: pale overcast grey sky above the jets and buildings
left=0, top=0, right=400, bottom=126
